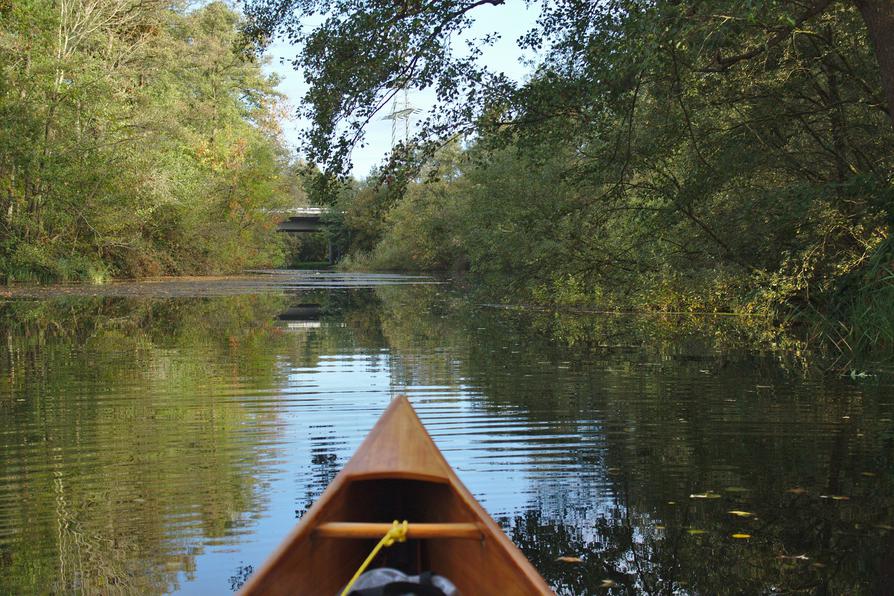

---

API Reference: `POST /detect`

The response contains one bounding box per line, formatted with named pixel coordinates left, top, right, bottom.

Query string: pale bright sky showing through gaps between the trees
left=266, top=0, right=540, bottom=179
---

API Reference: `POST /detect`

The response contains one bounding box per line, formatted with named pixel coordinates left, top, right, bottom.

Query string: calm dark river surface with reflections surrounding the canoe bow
left=0, top=273, right=894, bottom=594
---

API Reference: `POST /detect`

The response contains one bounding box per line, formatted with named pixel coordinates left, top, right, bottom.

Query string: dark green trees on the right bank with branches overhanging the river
left=272, top=0, right=894, bottom=358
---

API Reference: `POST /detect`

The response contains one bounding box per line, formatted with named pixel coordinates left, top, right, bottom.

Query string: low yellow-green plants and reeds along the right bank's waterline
left=340, top=260, right=894, bottom=372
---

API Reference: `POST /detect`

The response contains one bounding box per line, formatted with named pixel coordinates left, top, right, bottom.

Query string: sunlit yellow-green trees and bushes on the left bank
left=0, top=0, right=295, bottom=281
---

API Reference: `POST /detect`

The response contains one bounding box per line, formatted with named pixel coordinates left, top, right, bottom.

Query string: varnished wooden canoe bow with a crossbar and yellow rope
left=242, top=396, right=554, bottom=596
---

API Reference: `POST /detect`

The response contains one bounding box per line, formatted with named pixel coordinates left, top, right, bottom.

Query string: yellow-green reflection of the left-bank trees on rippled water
left=0, top=296, right=292, bottom=593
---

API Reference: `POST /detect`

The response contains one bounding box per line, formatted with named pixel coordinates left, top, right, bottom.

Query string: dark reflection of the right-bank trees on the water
left=377, top=288, right=894, bottom=594
